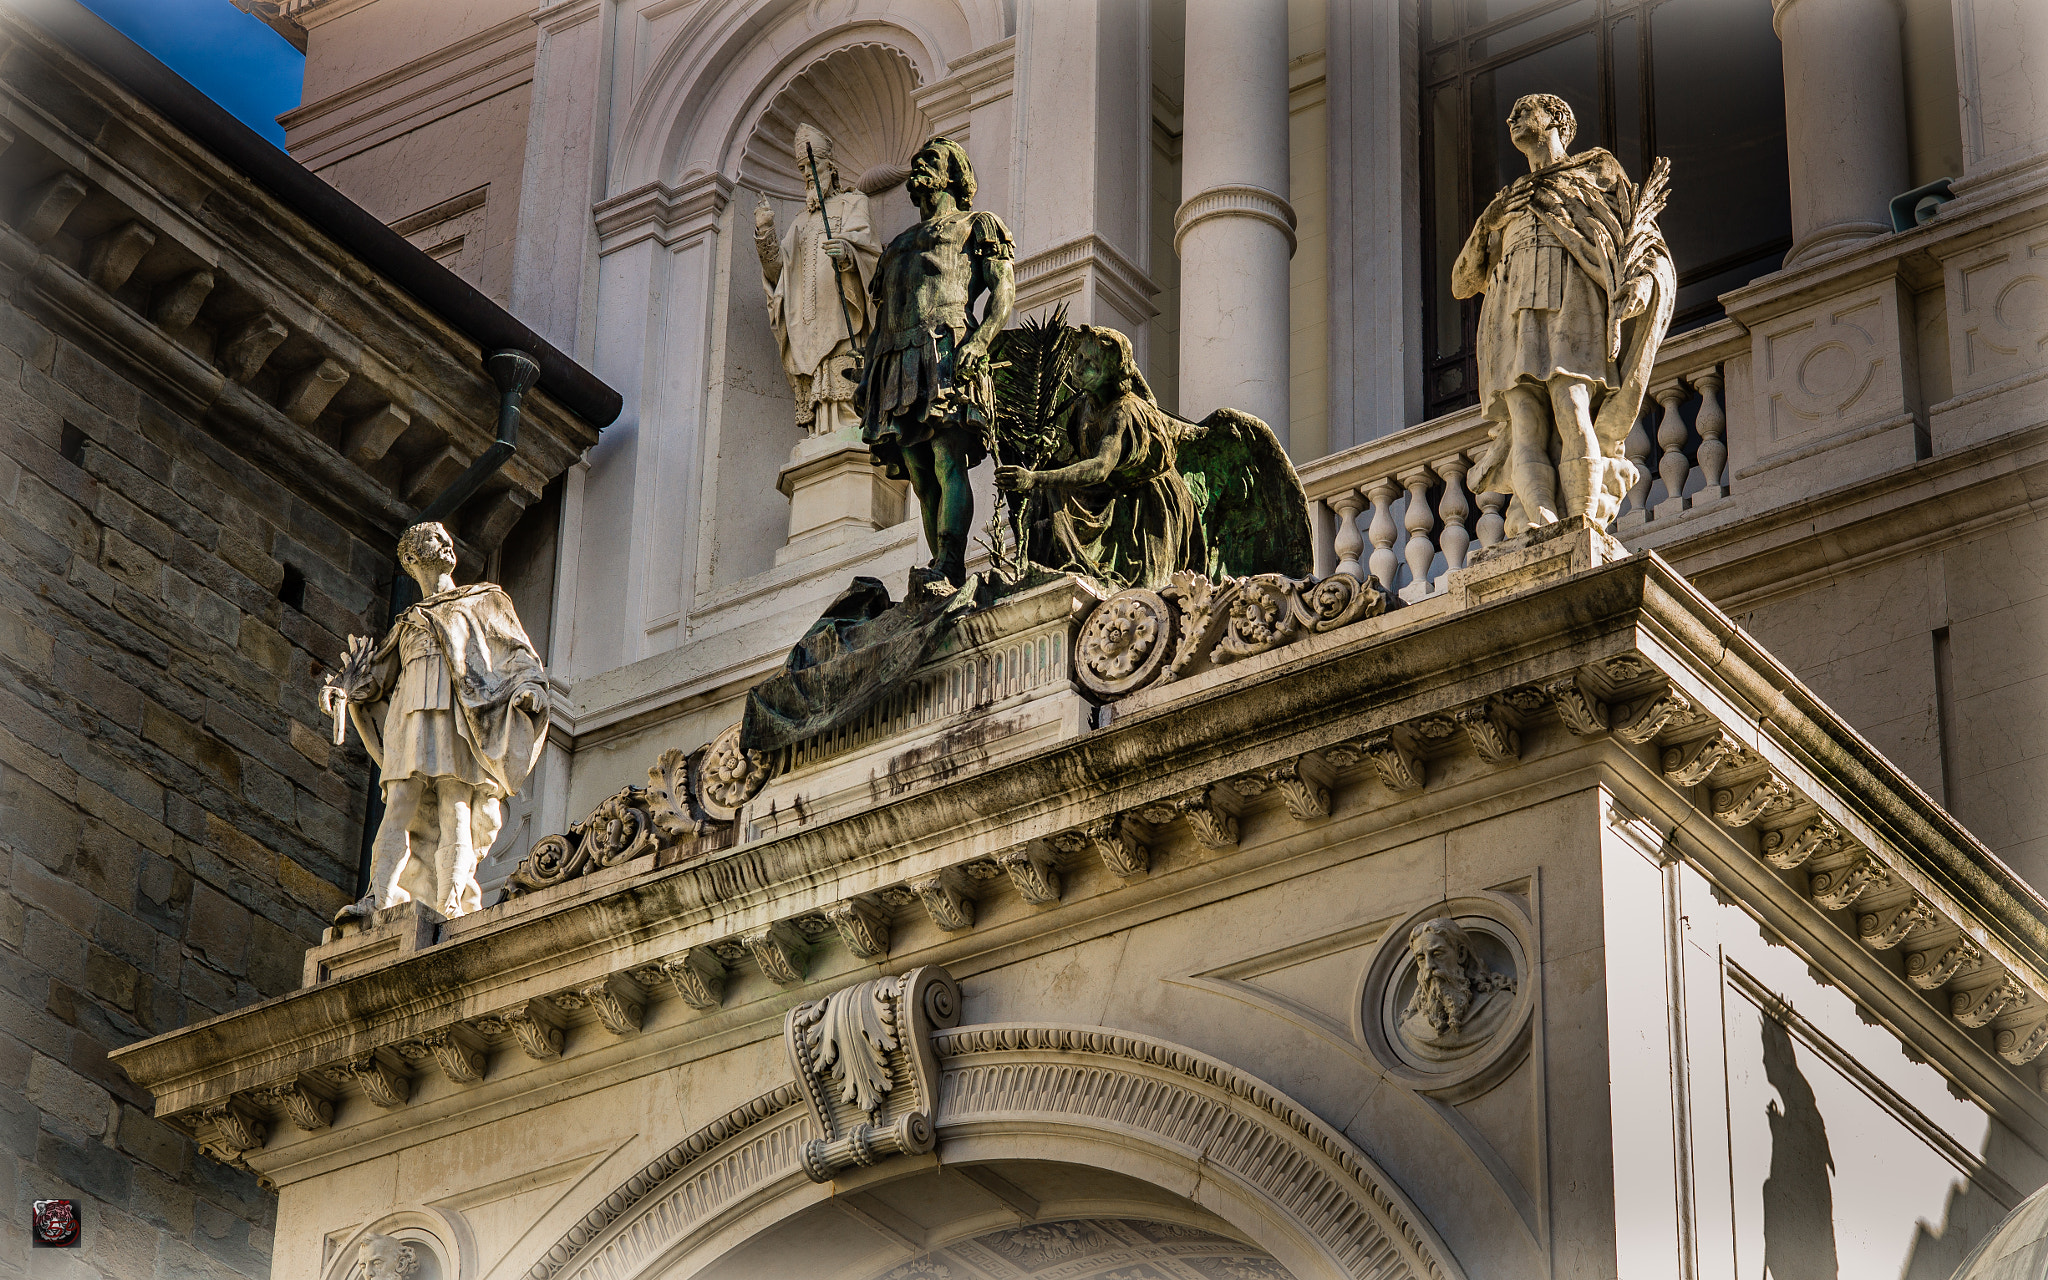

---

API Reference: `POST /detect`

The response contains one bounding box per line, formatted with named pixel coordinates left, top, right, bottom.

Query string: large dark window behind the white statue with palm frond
left=1421, top=0, right=1792, bottom=418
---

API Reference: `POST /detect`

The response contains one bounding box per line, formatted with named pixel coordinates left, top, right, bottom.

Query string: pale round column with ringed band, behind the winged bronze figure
left=1174, top=0, right=1294, bottom=442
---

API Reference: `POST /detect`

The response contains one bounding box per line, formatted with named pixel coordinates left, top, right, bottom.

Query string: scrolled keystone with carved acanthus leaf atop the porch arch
left=782, top=967, right=961, bottom=1182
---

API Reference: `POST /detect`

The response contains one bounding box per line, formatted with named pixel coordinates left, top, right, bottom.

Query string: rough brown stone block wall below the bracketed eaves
left=0, top=292, right=389, bottom=1280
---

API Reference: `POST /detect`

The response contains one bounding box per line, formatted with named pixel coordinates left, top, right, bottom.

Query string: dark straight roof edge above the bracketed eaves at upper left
left=18, top=0, right=625, bottom=430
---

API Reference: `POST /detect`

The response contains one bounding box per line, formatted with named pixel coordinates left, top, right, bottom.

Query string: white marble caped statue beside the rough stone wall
left=319, top=524, right=547, bottom=924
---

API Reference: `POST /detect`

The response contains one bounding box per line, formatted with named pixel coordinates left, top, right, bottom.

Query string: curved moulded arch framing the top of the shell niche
left=608, top=0, right=1010, bottom=195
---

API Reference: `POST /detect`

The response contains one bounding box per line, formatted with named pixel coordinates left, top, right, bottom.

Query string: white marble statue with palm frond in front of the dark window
left=1450, top=94, right=1677, bottom=537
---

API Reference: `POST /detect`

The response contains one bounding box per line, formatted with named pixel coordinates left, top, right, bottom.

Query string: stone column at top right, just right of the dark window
left=1772, top=0, right=1913, bottom=266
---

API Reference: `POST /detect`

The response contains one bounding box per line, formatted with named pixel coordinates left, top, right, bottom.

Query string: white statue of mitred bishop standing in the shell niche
left=754, top=125, right=883, bottom=436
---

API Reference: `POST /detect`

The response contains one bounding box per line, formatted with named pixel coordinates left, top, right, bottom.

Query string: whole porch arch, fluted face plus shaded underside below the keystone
left=526, top=1024, right=1464, bottom=1280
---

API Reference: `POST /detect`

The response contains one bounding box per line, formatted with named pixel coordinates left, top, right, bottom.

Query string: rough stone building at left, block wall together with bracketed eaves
left=0, top=10, right=596, bottom=1280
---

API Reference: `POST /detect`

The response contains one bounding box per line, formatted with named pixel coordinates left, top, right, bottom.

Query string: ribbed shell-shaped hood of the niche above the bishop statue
left=739, top=45, right=932, bottom=201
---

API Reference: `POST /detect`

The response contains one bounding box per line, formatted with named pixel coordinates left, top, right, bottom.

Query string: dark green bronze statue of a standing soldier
left=854, top=137, right=1016, bottom=586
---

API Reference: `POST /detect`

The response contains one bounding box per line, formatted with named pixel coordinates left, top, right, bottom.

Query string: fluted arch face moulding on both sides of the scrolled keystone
left=522, top=1024, right=1464, bottom=1280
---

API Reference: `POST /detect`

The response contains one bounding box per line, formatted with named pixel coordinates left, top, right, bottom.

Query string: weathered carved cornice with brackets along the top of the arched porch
left=115, top=553, right=2048, bottom=1149
